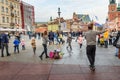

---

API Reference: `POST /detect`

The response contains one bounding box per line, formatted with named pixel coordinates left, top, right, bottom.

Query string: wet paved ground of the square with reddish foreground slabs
left=0, top=36, right=120, bottom=80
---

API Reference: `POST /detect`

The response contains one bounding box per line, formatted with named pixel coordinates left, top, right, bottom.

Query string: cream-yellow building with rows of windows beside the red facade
left=0, top=0, right=21, bottom=28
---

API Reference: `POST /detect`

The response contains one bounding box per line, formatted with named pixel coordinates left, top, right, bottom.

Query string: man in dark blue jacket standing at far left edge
left=1, top=32, right=10, bottom=57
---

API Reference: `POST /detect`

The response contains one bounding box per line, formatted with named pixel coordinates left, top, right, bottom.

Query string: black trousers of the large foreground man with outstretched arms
left=86, top=45, right=96, bottom=67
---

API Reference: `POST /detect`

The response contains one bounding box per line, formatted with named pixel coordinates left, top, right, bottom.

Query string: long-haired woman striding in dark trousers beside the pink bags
left=39, top=31, right=49, bottom=60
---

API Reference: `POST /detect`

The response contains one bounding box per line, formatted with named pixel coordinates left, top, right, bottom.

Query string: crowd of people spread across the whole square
left=0, top=22, right=120, bottom=71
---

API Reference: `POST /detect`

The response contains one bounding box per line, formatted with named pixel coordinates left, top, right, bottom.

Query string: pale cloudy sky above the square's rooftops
left=22, top=0, right=119, bottom=23
